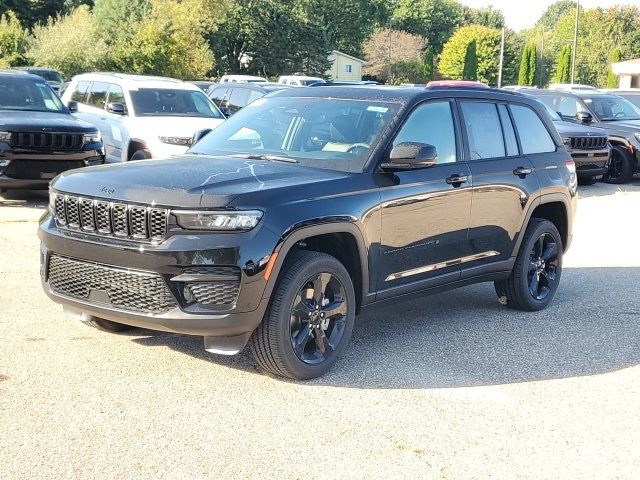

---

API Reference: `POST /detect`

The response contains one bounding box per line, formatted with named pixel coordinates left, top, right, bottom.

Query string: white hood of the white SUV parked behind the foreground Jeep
left=129, top=117, right=225, bottom=138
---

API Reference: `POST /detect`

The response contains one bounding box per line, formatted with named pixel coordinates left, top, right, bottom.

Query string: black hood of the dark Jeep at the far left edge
left=0, top=110, right=96, bottom=132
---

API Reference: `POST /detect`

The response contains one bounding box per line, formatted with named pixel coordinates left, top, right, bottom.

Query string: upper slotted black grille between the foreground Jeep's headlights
left=54, top=194, right=169, bottom=242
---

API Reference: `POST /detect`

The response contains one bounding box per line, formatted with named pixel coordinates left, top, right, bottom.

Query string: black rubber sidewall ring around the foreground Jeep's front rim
left=269, top=254, right=356, bottom=379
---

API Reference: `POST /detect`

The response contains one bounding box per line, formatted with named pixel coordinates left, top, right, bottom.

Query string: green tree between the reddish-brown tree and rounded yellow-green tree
left=393, top=0, right=463, bottom=54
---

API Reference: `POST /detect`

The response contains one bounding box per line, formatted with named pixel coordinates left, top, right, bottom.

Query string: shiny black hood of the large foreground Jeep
left=51, top=155, right=349, bottom=208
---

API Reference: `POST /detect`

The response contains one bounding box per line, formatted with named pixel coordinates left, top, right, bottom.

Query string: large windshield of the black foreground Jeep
left=190, top=97, right=399, bottom=172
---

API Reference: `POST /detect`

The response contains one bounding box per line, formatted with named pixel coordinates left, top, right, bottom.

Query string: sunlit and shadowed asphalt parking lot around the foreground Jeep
left=0, top=180, right=640, bottom=479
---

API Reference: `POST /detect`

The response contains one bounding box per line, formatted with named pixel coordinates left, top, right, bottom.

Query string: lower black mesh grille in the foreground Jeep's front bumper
left=48, top=255, right=177, bottom=314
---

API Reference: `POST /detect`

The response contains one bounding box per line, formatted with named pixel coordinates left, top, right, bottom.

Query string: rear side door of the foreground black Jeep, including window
left=459, top=99, right=539, bottom=278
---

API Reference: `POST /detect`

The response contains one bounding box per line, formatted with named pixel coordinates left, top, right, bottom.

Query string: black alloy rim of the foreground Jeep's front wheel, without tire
left=290, top=272, right=348, bottom=365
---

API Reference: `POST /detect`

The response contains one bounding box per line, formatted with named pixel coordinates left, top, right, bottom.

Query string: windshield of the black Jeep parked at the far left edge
left=0, top=77, right=66, bottom=113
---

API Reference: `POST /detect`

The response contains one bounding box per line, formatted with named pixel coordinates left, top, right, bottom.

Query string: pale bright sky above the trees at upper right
left=460, top=0, right=640, bottom=31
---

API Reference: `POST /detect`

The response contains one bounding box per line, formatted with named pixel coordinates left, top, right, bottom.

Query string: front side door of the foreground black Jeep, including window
left=378, top=99, right=472, bottom=299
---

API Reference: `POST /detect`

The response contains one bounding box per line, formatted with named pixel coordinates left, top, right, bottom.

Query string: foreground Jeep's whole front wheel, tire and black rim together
left=249, top=251, right=356, bottom=380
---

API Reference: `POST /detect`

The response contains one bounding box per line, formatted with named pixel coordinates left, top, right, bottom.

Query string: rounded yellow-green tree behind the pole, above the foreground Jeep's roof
left=438, top=25, right=521, bottom=85
